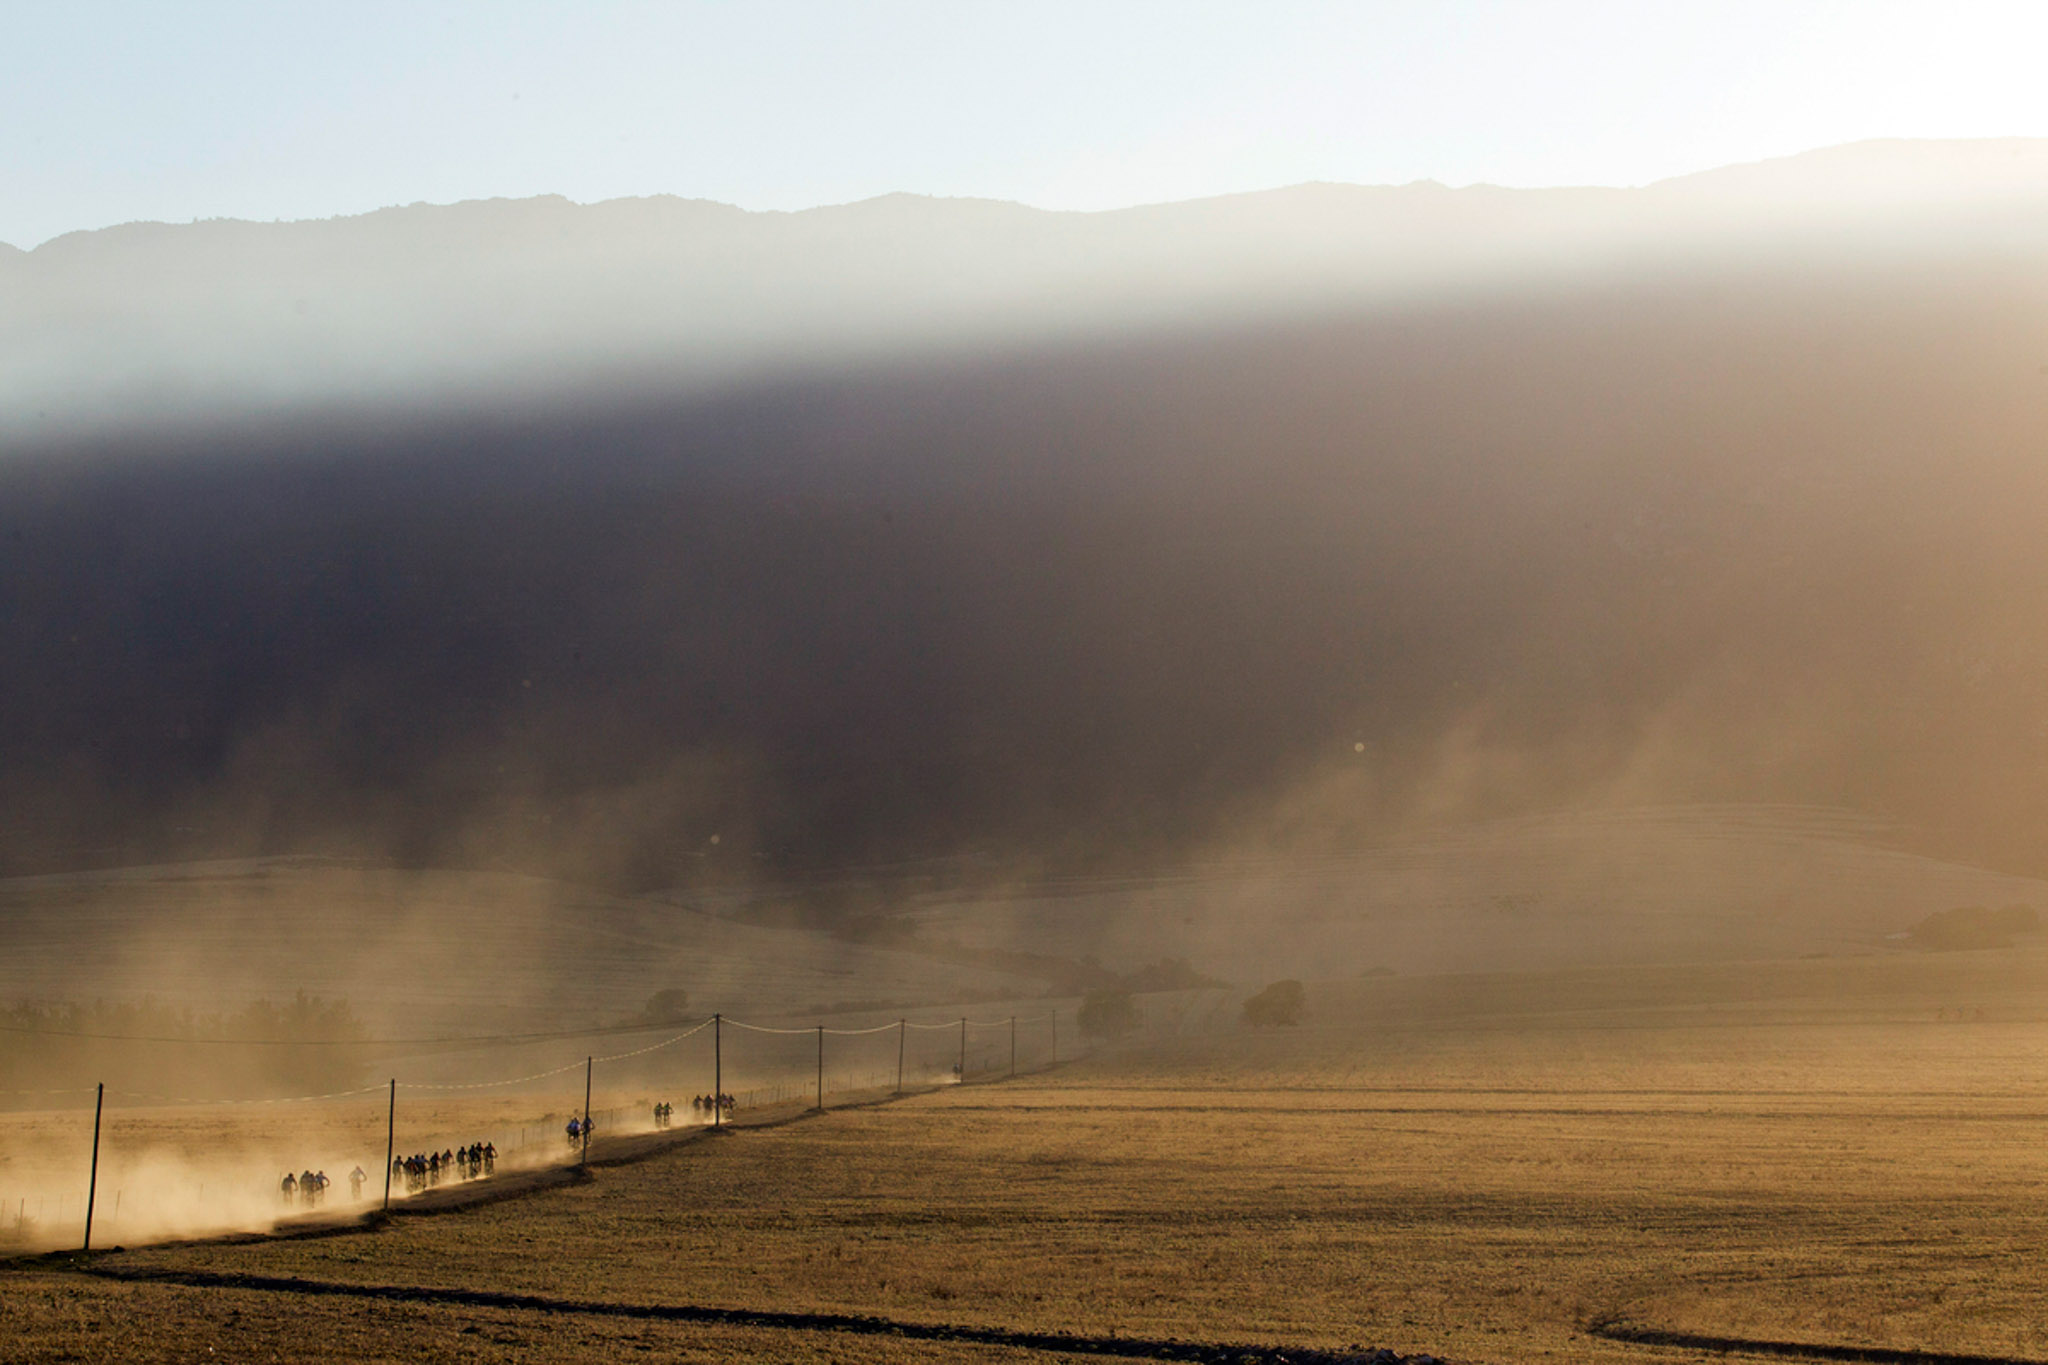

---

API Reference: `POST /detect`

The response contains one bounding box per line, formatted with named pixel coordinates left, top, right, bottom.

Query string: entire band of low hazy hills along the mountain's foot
left=0, top=806, right=2048, bottom=1038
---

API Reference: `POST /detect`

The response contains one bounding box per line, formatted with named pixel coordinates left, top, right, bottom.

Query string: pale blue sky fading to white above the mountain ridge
left=0, top=0, right=2048, bottom=248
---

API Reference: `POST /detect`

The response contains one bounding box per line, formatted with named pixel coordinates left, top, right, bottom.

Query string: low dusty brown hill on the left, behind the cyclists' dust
left=0, top=860, right=1044, bottom=1036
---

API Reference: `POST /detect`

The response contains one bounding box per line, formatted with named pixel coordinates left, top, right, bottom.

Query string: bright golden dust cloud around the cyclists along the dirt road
left=0, top=999, right=1048, bottom=1252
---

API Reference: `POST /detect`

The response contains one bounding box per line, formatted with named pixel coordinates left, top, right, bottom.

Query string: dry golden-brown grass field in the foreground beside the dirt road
left=12, top=948, right=2048, bottom=1361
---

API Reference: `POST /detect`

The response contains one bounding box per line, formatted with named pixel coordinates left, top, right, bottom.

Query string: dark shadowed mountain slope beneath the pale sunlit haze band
left=0, top=144, right=2048, bottom=888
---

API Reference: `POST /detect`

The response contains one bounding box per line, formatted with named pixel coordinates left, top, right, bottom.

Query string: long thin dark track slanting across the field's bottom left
left=78, top=1265, right=1442, bottom=1365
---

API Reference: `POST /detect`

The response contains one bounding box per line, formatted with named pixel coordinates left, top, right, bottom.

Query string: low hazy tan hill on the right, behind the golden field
left=899, top=806, right=2048, bottom=988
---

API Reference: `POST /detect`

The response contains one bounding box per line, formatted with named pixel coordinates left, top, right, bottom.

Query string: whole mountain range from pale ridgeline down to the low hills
left=12, top=143, right=2048, bottom=892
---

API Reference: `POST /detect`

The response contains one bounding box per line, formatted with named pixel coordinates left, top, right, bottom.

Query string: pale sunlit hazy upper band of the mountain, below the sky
left=12, top=141, right=2048, bottom=440
